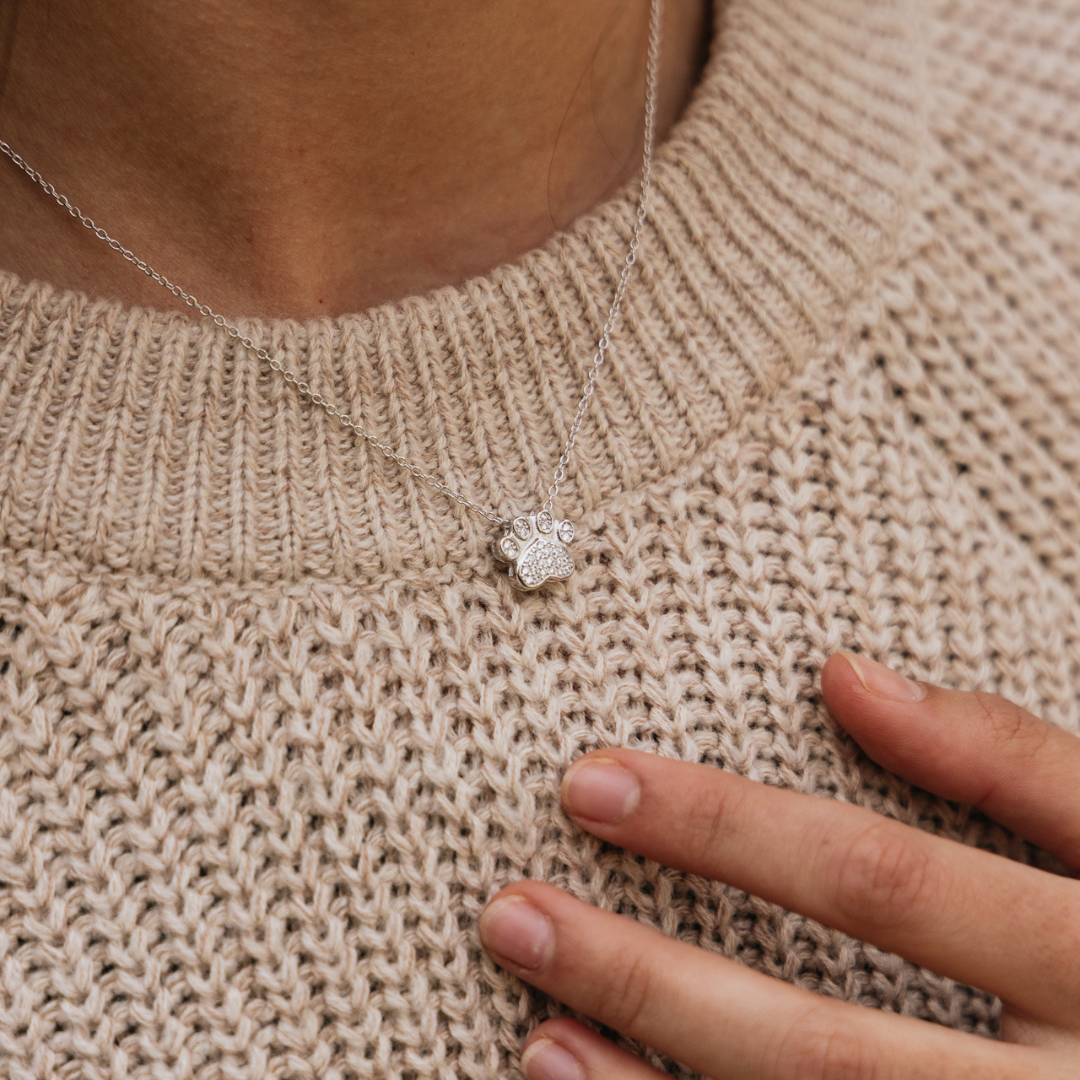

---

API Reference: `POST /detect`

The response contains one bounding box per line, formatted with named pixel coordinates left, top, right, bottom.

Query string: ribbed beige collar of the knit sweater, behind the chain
left=0, top=0, right=923, bottom=585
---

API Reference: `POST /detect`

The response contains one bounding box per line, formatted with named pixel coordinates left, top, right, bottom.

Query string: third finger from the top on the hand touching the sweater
left=481, top=881, right=1054, bottom=1080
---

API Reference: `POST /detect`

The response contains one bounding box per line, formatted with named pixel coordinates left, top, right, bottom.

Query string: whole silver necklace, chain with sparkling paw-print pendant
left=0, top=0, right=663, bottom=592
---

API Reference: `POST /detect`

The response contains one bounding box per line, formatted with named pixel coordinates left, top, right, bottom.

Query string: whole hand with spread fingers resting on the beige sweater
left=481, top=653, right=1080, bottom=1080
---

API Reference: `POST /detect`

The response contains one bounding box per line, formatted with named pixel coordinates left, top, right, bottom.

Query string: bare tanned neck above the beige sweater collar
left=0, top=0, right=707, bottom=318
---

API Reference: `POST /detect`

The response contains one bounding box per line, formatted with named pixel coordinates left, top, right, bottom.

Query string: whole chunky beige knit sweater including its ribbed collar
left=0, top=0, right=1080, bottom=1080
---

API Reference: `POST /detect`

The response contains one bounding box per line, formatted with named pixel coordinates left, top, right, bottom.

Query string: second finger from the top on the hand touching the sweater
left=564, top=750, right=1080, bottom=1028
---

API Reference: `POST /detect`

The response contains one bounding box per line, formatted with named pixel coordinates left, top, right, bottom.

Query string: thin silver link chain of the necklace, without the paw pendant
left=0, top=0, right=663, bottom=528
